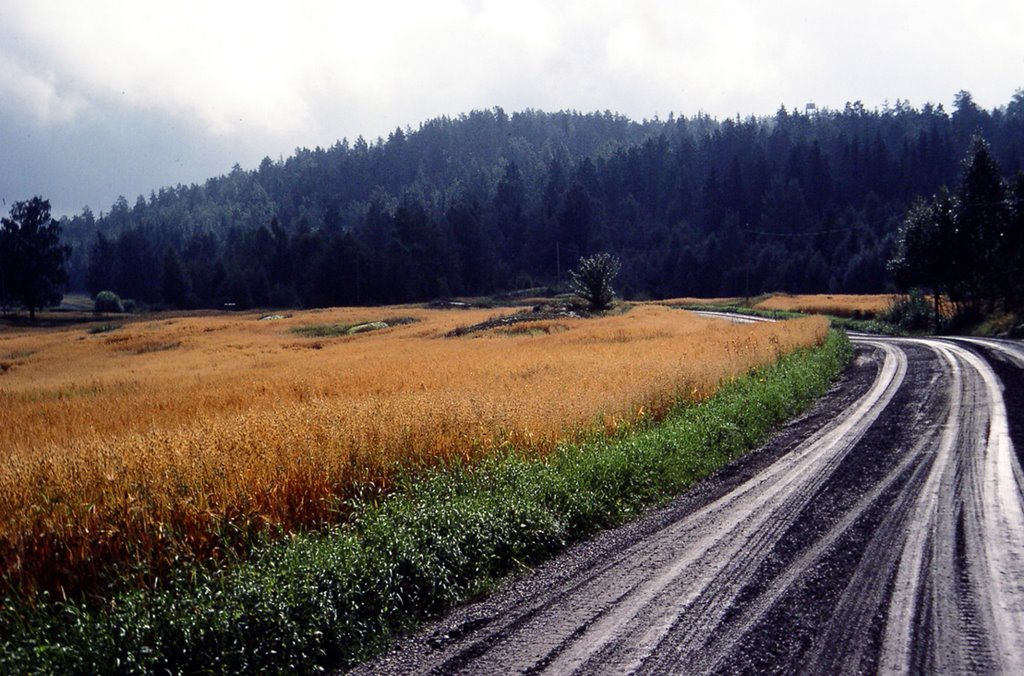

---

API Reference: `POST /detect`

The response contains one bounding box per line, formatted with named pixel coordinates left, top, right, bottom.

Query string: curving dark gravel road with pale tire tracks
left=358, top=329, right=1024, bottom=674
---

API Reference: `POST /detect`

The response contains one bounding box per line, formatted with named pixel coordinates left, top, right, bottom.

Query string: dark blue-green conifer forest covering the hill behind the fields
left=63, top=90, right=1024, bottom=307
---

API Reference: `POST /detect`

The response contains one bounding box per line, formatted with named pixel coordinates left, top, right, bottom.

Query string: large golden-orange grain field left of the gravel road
left=0, top=306, right=827, bottom=588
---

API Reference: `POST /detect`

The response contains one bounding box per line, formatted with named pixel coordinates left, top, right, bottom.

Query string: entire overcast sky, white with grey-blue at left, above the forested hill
left=0, top=0, right=1024, bottom=214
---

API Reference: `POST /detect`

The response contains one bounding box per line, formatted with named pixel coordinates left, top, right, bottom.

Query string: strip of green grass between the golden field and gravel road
left=0, top=331, right=851, bottom=673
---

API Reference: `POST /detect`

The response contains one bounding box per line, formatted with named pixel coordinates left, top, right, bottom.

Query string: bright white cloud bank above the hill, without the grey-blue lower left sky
left=0, top=0, right=1024, bottom=136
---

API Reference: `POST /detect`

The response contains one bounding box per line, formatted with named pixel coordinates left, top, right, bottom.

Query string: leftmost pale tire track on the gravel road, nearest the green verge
left=551, top=346, right=906, bottom=673
